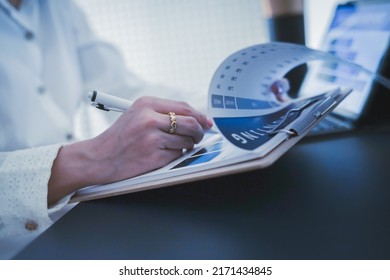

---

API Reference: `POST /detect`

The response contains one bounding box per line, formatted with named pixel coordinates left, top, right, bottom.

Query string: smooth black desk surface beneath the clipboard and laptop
left=17, top=128, right=390, bottom=259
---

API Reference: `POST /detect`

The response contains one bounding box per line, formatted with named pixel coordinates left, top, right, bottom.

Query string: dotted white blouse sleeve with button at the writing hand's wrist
left=0, top=144, right=67, bottom=239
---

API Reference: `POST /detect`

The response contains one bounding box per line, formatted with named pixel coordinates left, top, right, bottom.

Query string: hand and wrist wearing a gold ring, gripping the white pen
left=48, top=97, right=212, bottom=203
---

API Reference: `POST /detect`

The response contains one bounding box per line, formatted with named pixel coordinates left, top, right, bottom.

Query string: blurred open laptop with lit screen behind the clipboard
left=299, top=0, right=390, bottom=135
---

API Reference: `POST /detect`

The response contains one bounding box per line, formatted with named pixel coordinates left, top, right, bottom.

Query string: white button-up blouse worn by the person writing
left=0, top=0, right=172, bottom=256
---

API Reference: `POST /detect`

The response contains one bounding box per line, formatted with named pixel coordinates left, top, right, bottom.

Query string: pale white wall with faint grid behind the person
left=74, top=0, right=267, bottom=97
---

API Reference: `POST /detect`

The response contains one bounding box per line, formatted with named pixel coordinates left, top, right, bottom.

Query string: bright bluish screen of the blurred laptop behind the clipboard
left=300, top=1, right=390, bottom=119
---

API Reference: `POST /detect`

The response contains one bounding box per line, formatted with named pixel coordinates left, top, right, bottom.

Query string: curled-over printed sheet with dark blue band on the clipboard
left=208, top=43, right=390, bottom=150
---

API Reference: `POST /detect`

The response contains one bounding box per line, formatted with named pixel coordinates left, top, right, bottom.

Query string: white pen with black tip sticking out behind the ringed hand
left=88, top=90, right=133, bottom=113
